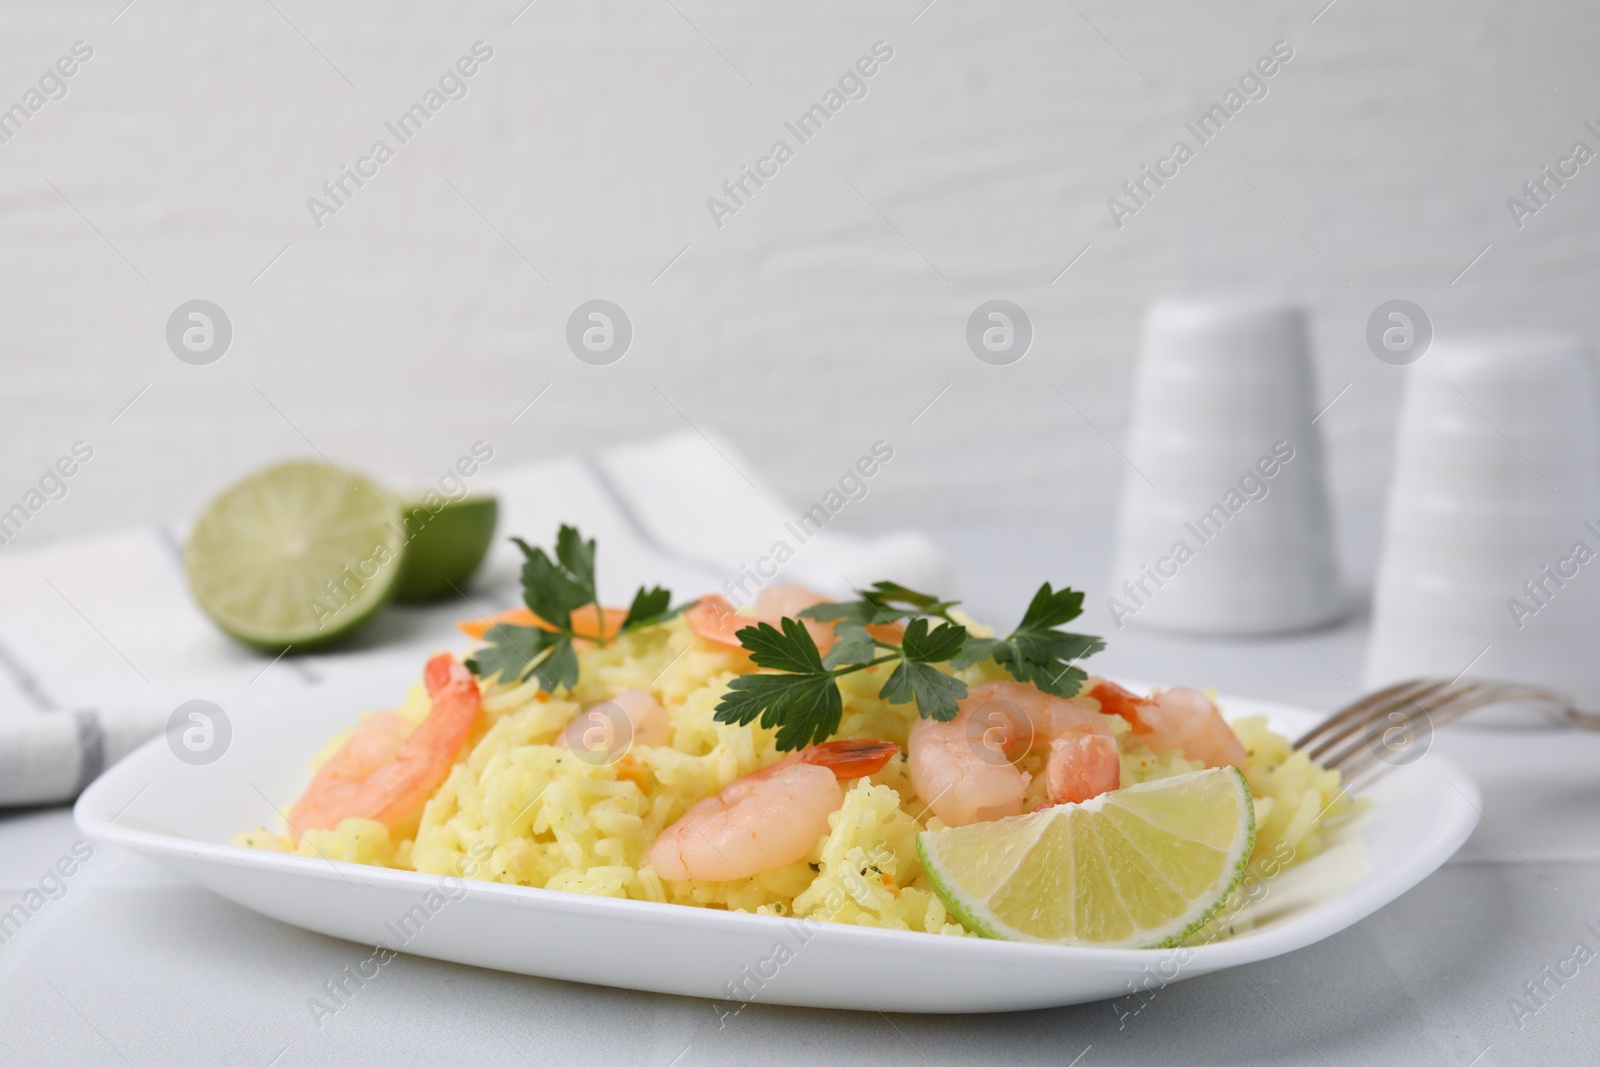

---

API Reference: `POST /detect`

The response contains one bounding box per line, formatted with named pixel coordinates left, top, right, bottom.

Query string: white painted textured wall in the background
left=0, top=0, right=1600, bottom=541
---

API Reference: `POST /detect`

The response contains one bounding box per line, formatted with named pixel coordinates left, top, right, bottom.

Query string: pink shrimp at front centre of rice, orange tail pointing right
left=650, top=741, right=899, bottom=881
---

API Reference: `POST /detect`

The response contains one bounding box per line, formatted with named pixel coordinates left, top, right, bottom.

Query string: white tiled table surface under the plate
left=0, top=523, right=1600, bottom=1067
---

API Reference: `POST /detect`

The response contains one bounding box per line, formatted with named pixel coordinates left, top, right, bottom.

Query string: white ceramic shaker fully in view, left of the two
left=1107, top=299, right=1344, bottom=635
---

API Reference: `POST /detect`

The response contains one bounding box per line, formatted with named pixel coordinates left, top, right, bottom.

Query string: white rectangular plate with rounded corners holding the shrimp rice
left=74, top=673, right=1482, bottom=1011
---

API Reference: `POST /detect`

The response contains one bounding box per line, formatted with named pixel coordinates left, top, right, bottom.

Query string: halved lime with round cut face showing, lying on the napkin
left=184, top=462, right=403, bottom=651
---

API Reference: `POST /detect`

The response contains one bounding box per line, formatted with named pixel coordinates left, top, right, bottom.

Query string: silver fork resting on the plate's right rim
left=1294, top=678, right=1600, bottom=782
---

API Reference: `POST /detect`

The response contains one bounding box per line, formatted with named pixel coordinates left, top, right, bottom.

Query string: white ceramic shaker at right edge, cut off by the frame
left=1366, top=334, right=1600, bottom=723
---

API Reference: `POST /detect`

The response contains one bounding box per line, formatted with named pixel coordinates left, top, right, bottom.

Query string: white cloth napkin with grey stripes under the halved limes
left=0, top=432, right=949, bottom=805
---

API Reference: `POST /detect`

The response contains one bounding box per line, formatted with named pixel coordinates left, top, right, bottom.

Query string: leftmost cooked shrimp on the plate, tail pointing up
left=288, top=654, right=483, bottom=845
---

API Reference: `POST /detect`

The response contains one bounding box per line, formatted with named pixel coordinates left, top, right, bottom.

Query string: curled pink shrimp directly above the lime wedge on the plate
left=907, top=681, right=1122, bottom=825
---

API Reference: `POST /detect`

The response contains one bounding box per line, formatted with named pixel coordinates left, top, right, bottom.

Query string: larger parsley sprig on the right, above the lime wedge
left=717, top=582, right=1106, bottom=750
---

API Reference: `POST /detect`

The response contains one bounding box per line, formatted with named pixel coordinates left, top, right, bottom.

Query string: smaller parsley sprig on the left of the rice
left=467, top=526, right=683, bottom=691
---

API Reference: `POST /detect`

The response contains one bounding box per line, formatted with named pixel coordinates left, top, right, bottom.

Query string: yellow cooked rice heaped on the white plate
left=240, top=616, right=1360, bottom=939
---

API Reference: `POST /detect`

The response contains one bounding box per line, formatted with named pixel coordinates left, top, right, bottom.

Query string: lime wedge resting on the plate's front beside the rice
left=917, top=766, right=1256, bottom=949
